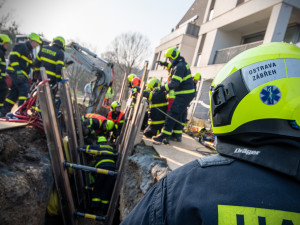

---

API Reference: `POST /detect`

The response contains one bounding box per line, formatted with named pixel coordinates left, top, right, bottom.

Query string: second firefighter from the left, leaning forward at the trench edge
left=0, top=33, right=42, bottom=117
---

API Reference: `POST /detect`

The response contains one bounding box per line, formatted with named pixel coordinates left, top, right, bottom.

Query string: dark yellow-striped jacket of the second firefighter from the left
left=7, top=41, right=33, bottom=78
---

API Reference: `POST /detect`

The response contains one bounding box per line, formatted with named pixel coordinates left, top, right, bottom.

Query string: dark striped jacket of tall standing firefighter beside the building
left=162, top=56, right=195, bottom=96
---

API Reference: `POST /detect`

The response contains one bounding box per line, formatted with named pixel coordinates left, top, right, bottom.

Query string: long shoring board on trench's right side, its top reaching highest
left=105, top=61, right=148, bottom=225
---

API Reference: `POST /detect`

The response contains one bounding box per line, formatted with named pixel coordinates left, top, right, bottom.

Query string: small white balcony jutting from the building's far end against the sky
left=160, top=23, right=200, bottom=44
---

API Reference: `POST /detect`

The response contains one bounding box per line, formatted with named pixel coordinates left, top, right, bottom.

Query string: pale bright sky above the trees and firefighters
left=0, top=0, right=194, bottom=57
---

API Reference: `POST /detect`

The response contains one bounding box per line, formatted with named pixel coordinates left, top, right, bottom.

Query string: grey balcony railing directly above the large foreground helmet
left=213, top=41, right=263, bottom=64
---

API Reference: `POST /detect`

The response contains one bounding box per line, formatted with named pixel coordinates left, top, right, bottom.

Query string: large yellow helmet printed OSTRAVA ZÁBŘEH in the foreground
left=210, top=42, right=300, bottom=137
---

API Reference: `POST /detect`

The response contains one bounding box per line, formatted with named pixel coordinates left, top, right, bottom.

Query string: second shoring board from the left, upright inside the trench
left=59, top=70, right=87, bottom=208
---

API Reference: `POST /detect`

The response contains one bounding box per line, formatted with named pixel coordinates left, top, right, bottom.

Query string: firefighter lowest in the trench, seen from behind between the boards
left=84, top=136, right=117, bottom=216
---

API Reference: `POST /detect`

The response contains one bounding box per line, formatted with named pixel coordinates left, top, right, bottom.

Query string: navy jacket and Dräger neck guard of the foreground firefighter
left=121, top=138, right=300, bottom=225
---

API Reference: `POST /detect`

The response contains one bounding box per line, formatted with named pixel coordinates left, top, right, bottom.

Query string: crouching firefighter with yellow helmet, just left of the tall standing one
left=144, top=78, right=168, bottom=138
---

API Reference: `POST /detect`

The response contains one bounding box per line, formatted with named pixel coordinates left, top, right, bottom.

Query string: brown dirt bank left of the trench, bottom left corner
left=0, top=126, right=53, bottom=225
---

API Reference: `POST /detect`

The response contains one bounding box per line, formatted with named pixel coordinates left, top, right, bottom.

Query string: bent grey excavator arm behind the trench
left=65, top=42, right=113, bottom=113
